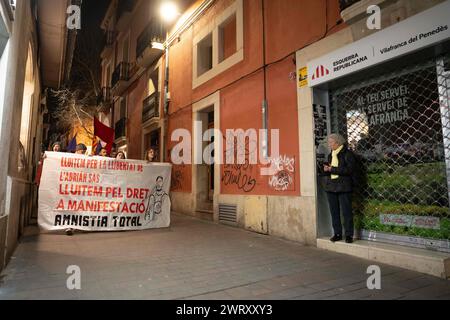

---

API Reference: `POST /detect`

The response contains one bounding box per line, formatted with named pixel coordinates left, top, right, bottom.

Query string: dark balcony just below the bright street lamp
left=136, top=19, right=165, bottom=68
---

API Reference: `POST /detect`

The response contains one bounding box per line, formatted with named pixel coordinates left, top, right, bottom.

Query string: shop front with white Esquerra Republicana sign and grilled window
left=299, top=1, right=450, bottom=253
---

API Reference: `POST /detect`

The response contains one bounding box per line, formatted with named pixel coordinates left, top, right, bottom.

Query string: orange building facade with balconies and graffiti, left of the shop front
left=100, top=0, right=340, bottom=242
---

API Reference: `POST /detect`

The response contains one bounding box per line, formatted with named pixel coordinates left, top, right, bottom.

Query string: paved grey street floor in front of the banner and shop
left=0, top=214, right=450, bottom=300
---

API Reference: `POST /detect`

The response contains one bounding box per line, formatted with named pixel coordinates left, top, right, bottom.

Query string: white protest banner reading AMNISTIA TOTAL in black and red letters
left=38, top=152, right=172, bottom=231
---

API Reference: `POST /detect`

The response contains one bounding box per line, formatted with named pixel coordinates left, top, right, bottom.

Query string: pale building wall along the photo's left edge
left=0, top=1, right=42, bottom=269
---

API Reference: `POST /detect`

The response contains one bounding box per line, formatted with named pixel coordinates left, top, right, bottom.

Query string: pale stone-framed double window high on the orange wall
left=193, top=0, right=244, bottom=88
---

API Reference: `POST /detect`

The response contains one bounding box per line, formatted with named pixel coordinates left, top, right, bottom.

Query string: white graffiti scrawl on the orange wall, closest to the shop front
left=269, top=155, right=295, bottom=191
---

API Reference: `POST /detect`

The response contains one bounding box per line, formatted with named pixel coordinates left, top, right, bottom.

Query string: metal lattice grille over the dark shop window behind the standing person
left=330, top=56, right=450, bottom=252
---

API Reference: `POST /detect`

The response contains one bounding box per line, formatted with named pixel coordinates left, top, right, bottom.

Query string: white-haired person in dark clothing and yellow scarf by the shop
left=324, top=134, right=356, bottom=243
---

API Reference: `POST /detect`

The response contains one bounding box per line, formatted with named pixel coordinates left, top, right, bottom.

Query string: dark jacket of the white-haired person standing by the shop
left=325, top=146, right=356, bottom=192
